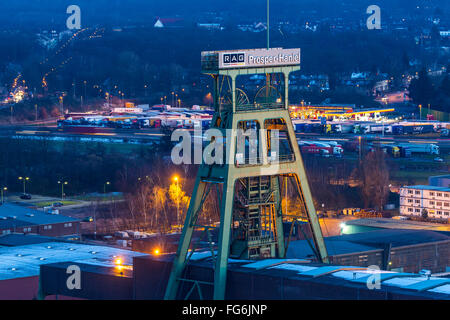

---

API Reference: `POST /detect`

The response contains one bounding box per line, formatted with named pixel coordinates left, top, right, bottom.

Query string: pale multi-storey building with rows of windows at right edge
left=400, top=185, right=450, bottom=220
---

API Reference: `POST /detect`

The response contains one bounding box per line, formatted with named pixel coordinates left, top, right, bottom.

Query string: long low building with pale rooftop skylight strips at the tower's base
left=136, top=251, right=450, bottom=299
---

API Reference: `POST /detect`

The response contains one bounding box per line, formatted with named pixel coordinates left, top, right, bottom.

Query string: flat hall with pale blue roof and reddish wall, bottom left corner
left=0, top=234, right=143, bottom=300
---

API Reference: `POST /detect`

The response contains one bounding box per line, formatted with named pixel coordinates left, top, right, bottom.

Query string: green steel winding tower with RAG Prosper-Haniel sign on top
left=165, top=48, right=328, bottom=300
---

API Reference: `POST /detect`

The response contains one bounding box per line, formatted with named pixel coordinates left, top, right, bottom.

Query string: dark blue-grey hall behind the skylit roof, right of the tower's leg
left=312, top=229, right=450, bottom=273
